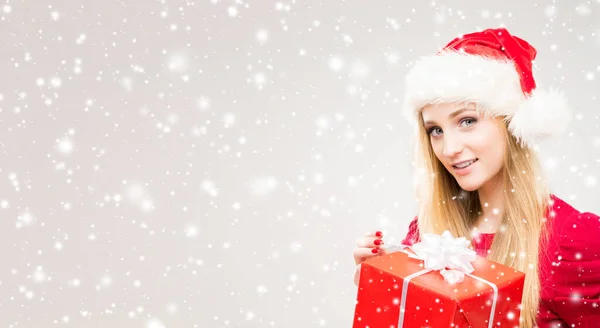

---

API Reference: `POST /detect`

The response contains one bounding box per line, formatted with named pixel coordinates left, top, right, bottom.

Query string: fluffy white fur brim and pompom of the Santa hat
left=404, top=51, right=571, bottom=147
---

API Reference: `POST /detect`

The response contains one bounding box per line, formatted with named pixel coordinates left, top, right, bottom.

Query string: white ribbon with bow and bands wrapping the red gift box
left=386, top=230, right=498, bottom=328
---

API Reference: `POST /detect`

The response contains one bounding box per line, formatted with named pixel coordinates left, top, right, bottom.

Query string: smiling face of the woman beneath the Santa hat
left=422, top=103, right=505, bottom=191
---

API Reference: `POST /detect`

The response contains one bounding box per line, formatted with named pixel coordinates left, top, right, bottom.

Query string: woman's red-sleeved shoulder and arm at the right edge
left=540, top=195, right=600, bottom=320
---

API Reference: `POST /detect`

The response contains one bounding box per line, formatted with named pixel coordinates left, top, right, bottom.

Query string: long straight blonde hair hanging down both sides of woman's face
left=414, top=109, right=550, bottom=328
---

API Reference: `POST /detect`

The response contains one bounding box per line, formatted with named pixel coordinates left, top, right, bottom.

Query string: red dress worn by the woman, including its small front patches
left=402, top=195, right=600, bottom=328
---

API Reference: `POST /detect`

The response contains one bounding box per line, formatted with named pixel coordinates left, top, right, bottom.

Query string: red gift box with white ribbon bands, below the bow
left=352, top=252, right=525, bottom=328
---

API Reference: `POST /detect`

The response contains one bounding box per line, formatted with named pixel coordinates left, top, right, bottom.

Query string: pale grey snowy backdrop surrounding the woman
left=0, top=0, right=600, bottom=328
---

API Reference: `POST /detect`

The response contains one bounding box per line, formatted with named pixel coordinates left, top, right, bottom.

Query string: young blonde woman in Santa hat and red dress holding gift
left=354, top=29, right=600, bottom=328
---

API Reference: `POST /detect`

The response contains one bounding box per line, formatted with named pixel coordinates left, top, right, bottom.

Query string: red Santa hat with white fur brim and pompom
left=404, top=28, right=571, bottom=147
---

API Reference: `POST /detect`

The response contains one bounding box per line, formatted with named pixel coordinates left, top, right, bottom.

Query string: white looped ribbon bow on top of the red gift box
left=390, top=230, right=477, bottom=284
